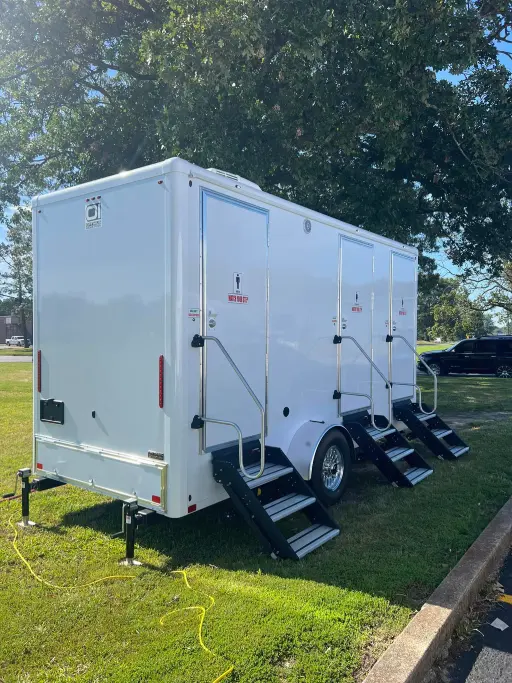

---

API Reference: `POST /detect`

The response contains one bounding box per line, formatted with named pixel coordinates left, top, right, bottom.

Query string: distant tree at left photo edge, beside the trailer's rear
left=0, top=207, right=32, bottom=347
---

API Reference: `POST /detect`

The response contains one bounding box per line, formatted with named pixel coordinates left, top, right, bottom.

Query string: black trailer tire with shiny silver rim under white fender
left=311, top=430, right=352, bottom=505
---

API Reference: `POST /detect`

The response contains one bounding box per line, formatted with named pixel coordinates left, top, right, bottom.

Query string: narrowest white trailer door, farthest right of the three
left=391, top=252, right=416, bottom=401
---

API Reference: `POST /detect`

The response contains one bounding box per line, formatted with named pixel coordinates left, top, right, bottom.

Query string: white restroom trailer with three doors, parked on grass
left=33, top=158, right=464, bottom=556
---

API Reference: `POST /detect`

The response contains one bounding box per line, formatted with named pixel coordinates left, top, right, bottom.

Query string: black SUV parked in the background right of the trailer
left=418, top=336, right=512, bottom=377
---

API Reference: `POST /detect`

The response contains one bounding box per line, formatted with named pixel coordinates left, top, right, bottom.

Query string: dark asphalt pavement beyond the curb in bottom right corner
left=447, top=555, right=512, bottom=683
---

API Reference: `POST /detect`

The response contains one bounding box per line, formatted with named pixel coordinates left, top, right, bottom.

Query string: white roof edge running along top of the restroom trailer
left=32, top=157, right=418, bottom=256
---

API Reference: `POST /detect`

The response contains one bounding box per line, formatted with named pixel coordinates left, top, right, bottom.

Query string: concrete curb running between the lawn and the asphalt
left=363, top=498, right=512, bottom=683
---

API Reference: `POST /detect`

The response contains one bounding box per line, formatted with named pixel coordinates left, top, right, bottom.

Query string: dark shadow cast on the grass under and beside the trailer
left=53, top=427, right=512, bottom=608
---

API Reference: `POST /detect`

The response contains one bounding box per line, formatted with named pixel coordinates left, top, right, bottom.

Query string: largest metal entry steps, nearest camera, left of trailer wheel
left=212, top=441, right=340, bottom=560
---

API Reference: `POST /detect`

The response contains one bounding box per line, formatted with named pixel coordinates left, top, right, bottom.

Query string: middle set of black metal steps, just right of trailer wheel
left=343, top=411, right=433, bottom=487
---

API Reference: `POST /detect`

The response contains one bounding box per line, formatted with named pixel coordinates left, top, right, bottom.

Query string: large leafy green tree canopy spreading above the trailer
left=0, top=0, right=512, bottom=269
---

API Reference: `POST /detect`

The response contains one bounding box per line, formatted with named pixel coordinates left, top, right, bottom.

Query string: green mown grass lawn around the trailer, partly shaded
left=0, top=364, right=512, bottom=683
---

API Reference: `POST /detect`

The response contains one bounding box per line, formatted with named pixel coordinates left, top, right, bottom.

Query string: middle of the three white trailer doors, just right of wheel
left=339, top=237, right=378, bottom=414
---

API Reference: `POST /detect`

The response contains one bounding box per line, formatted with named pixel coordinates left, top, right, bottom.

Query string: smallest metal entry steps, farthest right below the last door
left=394, top=400, right=469, bottom=460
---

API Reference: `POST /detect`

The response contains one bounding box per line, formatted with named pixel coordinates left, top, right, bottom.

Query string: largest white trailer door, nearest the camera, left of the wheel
left=202, top=190, right=268, bottom=450
